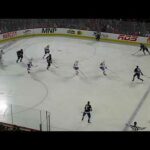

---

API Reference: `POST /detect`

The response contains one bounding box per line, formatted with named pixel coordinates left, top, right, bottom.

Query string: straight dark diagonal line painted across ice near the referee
left=123, top=86, right=150, bottom=131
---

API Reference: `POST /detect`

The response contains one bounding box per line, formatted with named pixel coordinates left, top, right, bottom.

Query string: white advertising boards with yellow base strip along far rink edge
left=0, top=28, right=150, bottom=46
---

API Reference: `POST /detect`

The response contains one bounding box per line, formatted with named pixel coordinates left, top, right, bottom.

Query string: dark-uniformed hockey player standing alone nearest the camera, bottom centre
left=82, top=101, right=92, bottom=123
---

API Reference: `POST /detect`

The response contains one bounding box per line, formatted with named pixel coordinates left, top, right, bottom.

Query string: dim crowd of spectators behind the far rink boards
left=0, top=18, right=150, bottom=37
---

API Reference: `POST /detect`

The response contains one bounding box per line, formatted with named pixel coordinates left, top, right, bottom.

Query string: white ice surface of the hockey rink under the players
left=0, top=37, right=150, bottom=131
